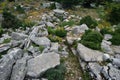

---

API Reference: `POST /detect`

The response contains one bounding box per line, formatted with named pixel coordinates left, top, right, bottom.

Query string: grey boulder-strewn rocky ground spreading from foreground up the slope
left=0, top=2, right=120, bottom=80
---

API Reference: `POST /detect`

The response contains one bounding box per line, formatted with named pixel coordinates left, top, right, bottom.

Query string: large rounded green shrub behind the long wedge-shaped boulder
left=80, top=30, right=103, bottom=50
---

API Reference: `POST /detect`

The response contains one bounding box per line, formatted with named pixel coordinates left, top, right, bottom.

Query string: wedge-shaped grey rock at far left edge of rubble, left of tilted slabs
left=11, top=32, right=28, bottom=40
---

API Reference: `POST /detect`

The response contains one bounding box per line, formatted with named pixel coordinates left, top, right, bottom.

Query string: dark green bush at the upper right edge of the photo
left=106, top=3, right=120, bottom=24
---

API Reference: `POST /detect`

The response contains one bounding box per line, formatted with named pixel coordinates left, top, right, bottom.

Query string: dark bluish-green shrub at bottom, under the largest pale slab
left=43, top=64, right=66, bottom=80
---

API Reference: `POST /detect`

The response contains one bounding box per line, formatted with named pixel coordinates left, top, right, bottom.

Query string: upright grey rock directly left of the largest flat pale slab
left=10, top=58, right=27, bottom=80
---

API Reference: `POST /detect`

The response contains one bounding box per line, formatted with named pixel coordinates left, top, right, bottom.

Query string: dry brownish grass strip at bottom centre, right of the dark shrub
left=62, top=53, right=82, bottom=80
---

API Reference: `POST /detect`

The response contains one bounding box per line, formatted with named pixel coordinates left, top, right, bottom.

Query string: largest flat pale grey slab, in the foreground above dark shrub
left=27, top=53, right=60, bottom=78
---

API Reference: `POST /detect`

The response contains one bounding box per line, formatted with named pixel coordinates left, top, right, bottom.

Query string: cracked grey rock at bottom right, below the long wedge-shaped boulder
left=88, top=63, right=102, bottom=80
